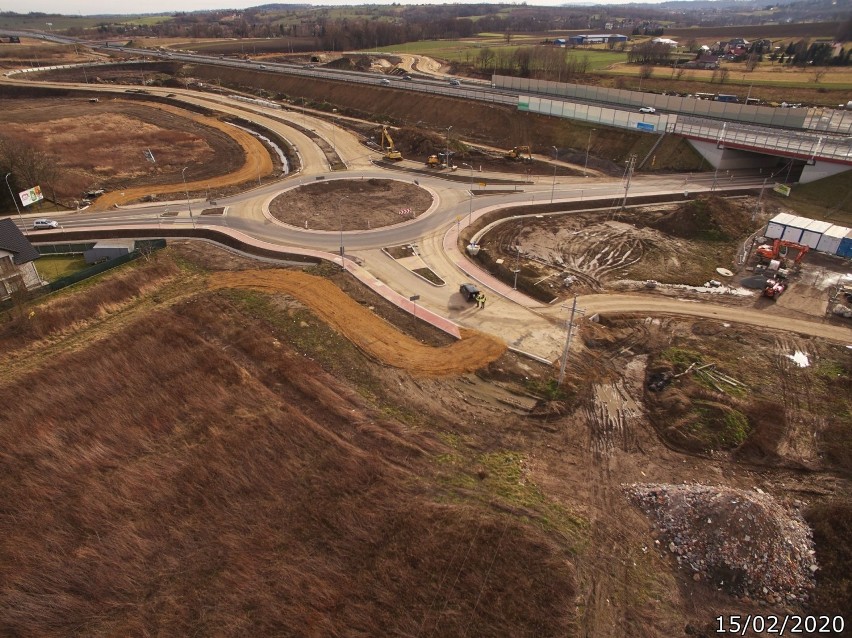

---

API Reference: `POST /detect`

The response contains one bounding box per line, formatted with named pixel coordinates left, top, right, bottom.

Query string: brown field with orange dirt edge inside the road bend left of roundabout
left=0, top=96, right=272, bottom=207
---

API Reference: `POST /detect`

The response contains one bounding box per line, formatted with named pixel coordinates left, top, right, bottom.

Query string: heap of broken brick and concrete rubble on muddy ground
left=625, top=484, right=817, bottom=604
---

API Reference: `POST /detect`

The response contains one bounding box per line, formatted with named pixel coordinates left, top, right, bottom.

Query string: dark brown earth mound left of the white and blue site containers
left=649, top=196, right=750, bottom=241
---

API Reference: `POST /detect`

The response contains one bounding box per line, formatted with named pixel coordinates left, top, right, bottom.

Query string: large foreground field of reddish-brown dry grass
left=0, top=252, right=575, bottom=636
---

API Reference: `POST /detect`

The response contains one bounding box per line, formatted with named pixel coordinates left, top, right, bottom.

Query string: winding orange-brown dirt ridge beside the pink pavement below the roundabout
left=210, top=270, right=506, bottom=375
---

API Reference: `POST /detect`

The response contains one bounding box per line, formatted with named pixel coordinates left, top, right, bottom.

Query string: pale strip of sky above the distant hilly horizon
left=10, top=0, right=636, bottom=15
